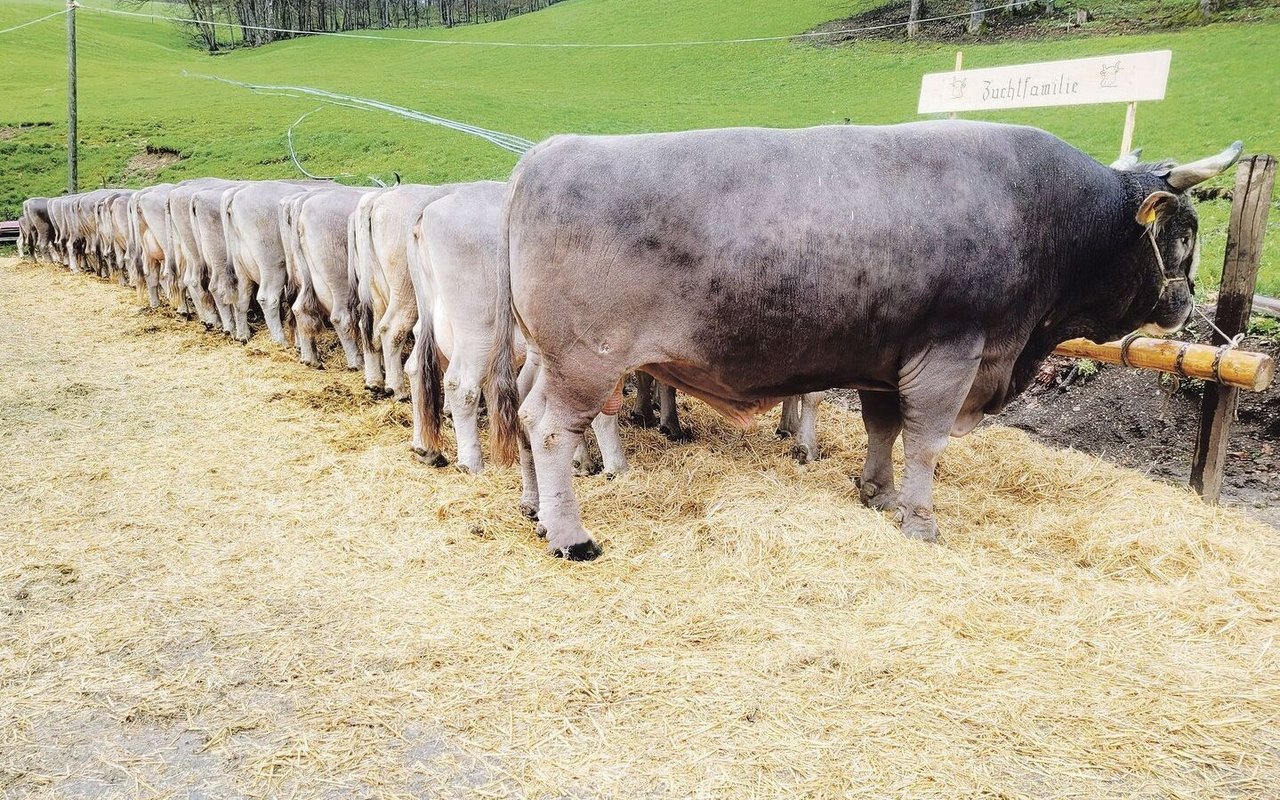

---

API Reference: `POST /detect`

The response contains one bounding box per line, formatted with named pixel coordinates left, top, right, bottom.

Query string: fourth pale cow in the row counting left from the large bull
left=221, top=180, right=332, bottom=346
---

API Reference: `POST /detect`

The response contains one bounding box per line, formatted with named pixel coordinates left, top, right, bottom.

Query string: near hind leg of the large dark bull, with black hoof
left=520, top=369, right=617, bottom=561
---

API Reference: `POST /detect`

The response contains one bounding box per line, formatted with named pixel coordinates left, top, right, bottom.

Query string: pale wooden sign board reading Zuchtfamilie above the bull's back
left=918, top=50, right=1172, bottom=114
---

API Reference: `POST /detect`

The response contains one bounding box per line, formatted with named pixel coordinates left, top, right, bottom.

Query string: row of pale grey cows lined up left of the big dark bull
left=19, top=178, right=721, bottom=475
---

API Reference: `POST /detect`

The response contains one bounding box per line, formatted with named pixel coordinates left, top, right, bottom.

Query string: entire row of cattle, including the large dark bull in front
left=23, top=122, right=1242, bottom=559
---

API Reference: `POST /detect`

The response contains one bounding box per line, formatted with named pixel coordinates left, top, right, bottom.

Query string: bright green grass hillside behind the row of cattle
left=0, top=0, right=1280, bottom=293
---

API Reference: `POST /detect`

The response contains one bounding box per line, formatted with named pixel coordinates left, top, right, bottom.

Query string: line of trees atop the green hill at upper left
left=171, top=0, right=559, bottom=52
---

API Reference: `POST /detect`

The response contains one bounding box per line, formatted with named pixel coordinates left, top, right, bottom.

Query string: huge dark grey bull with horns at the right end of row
left=489, top=122, right=1242, bottom=558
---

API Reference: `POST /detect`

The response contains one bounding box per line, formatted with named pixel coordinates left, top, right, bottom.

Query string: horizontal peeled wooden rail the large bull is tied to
left=1053, top=338, right=1276, bottom=392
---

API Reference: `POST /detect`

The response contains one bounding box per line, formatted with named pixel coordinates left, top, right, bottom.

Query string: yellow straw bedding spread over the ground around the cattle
left=0, top=261, right=1280, bottom=797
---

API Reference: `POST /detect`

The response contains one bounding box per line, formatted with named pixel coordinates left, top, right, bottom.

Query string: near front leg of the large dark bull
left=899, top=339, right=982, bottom=541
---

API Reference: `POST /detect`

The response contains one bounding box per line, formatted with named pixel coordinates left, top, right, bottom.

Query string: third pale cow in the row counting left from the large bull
left=280, top=187, right=369, bottom=370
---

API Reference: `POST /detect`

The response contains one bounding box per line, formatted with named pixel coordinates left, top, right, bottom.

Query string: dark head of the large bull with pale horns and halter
left=1112, top=142, right=1244, bottom=335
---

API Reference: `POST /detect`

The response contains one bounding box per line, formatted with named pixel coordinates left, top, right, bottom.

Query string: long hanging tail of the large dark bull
left=485, top=174, right=524, bottom=466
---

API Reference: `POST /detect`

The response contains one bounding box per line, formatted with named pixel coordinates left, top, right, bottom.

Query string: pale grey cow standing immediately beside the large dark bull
left=406, top=180, right=627, bottom=481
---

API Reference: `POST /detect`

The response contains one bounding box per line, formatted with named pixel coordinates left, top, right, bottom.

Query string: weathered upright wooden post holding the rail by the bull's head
left=1192, top=156, right=1276, bottom=506
